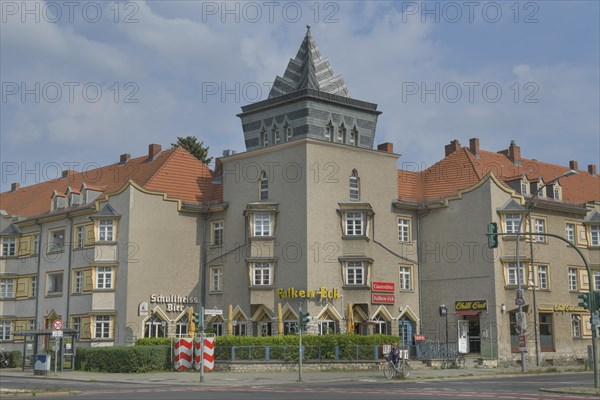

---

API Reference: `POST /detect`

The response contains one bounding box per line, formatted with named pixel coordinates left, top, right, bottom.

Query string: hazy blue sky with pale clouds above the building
left=0, top=0, right=600, bottom=191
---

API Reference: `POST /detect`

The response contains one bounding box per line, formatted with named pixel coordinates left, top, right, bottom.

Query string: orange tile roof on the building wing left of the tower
left=0, top=148, right=222, bottom=217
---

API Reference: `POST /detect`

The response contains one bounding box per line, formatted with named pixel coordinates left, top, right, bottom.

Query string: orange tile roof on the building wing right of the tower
left=398, top=147, right=600, bottom=204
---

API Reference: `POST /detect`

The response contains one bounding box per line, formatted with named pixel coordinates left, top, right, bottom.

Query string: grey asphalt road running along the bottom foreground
left=2, top=373, right=594, bottom=400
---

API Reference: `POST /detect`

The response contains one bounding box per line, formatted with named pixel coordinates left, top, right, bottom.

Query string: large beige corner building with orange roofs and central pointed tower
left=0, top=29, right=600, bottom=366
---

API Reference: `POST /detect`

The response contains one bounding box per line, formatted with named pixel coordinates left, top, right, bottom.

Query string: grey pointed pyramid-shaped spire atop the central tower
left=269, top=25, right=350, bottom=99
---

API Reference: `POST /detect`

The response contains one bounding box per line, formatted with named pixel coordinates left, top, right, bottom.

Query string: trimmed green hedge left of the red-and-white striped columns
left=75, top=345, right=172, bottom=373
